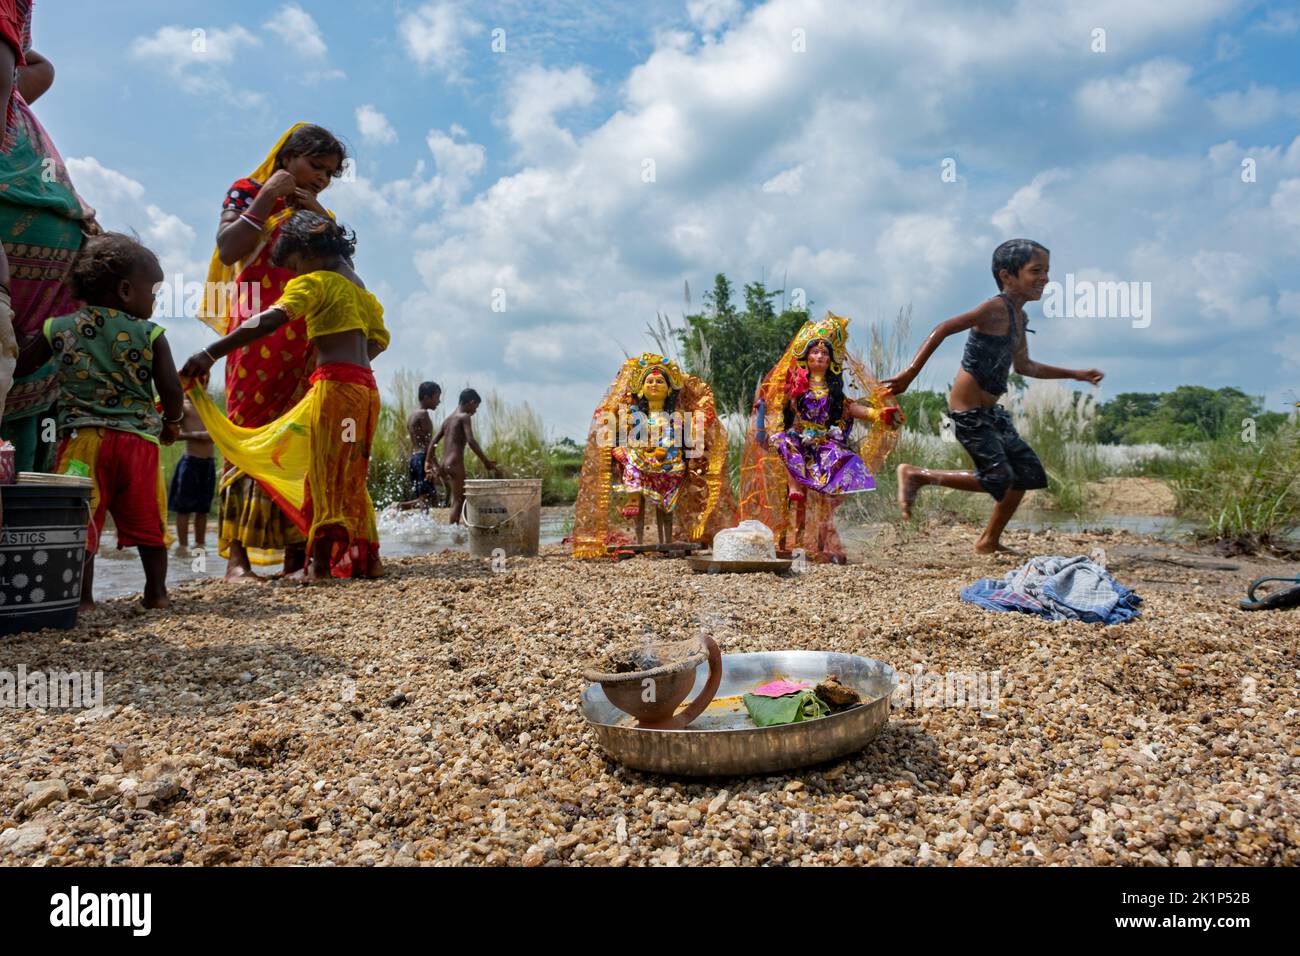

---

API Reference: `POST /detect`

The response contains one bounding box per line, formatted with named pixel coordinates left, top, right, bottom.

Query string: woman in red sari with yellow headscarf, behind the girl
left=199, top=124, right=347, bottom=580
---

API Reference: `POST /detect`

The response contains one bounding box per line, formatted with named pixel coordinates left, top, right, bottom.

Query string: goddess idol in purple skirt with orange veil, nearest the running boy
left=740, top=312, right=902, bottom=563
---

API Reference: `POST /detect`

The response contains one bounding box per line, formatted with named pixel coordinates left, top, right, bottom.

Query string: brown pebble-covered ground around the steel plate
left=0, top=527, right=1300, bottom=866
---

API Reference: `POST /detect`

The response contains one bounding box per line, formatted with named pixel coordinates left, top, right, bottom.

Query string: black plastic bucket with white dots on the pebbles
left=0, top=476, right=90, bottom=635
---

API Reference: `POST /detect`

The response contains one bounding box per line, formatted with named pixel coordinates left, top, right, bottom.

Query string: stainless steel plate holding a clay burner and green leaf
left=582, top=650, right=898, bottom=777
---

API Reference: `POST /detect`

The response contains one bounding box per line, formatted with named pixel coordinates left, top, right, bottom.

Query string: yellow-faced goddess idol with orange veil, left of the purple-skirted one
left=573, top=352, right=736, bottom=558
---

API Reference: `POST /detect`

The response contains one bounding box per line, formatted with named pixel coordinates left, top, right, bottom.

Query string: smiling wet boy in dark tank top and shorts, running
left=884, top=239, right=1102, bottom=554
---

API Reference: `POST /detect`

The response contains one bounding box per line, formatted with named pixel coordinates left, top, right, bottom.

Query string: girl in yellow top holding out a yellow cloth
left=181, top=211, right=389, bottom=580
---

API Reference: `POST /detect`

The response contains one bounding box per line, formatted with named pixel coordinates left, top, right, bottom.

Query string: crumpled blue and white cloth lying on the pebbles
left=962, top=554, right=1141, bottom=624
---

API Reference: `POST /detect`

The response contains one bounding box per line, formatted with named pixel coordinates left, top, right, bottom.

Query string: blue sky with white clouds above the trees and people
left=34, top=0, right=1300, bottom=437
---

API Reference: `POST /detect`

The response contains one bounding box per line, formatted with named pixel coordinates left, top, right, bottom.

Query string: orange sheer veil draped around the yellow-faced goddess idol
left=573, top=363, right=736, bottom=558
